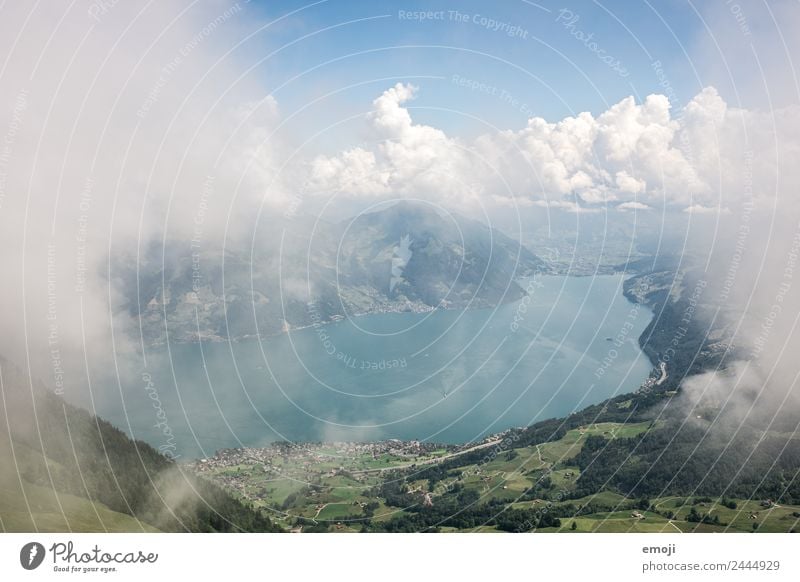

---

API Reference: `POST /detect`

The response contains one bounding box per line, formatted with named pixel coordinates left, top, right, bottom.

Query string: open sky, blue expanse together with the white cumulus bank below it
left=206, top=0, right=800, bottom=219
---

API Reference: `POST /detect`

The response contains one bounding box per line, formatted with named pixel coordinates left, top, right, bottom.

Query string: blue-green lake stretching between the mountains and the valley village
left=89, top=275, right=652, bottom=458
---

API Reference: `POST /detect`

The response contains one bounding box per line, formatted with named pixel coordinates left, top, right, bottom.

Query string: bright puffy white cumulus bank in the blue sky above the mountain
left=311, top=83, right=800, bottom=213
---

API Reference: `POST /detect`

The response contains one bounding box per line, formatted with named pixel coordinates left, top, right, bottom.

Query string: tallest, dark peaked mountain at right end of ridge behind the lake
left=330, top=202, right=541, bottom=311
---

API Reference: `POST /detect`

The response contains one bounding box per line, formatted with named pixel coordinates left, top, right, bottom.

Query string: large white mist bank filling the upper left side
left=0, top=0, right=286, bottom=380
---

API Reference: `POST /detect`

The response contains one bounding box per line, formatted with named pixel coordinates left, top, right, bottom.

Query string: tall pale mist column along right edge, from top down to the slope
left=682, top=0, right=800, bottom=434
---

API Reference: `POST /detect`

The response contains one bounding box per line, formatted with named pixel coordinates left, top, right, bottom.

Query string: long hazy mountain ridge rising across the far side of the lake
left=126, top=202, right=546, bottom=342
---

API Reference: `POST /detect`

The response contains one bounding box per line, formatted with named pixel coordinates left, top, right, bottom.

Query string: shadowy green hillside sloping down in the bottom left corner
left=0, top=358, right=280, bottom=532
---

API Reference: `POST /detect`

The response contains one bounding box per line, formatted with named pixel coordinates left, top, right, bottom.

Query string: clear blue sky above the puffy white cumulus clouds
left=244, top=0, right=703, bottom=141
